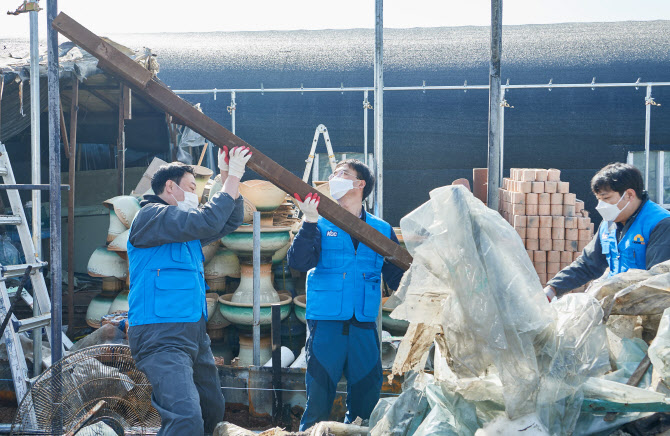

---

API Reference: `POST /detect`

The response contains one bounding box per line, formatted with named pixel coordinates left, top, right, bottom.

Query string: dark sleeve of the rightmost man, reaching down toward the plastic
left=547, top=233, right=609, bottom=295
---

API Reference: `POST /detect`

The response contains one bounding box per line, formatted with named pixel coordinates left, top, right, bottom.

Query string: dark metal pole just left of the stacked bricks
left=487, top=0, right=502, bottom=209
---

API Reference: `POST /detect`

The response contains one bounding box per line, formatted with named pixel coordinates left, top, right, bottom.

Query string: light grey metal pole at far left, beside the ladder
left=29, top=3, right=46, bottom=377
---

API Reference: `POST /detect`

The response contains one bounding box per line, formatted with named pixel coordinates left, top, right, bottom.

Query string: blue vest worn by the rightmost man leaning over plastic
left=598, top=201, right=670, bottom=276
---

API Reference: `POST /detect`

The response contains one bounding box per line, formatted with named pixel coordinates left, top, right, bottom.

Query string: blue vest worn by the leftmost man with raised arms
left=128, top=223, right=207, bottom=326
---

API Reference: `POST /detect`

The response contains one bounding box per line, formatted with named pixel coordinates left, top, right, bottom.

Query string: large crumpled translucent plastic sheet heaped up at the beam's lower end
left=389, top=186, right=609, bottom=434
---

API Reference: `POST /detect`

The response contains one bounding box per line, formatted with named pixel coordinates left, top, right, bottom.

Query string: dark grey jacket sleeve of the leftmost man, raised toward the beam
left=129, top=192, right=244, bottom=248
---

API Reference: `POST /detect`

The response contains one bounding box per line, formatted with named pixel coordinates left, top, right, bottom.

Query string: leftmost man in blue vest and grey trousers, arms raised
left=128, top=147, right=251, bottom=436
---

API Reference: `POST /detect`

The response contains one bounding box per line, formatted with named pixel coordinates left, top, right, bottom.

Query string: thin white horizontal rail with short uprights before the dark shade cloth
left=174, top=77, right=670, bottom=210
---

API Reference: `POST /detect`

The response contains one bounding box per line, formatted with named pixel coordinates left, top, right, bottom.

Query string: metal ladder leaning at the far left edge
left=0, top=143, right=72, bottom=404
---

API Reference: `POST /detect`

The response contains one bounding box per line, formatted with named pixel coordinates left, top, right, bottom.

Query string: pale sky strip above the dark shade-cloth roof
left=0, top=0, right=670, bottom=38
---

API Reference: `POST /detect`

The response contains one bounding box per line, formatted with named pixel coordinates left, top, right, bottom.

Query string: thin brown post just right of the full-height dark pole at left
left=64, top=75, right=79, bottom=333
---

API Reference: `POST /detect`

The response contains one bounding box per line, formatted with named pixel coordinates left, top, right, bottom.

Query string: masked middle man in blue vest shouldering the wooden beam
left=288, top=159, right=403, bottom=431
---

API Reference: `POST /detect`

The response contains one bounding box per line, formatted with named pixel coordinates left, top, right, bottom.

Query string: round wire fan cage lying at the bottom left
left=11, top=345, right=161, bottom=435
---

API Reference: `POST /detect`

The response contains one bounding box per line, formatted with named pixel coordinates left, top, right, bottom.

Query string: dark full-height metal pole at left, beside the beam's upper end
left=47, top=0, right=63, bottom=434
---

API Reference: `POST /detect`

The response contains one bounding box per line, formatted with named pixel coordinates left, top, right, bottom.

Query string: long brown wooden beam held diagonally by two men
left=53, top=12, right=412, bottom=270
